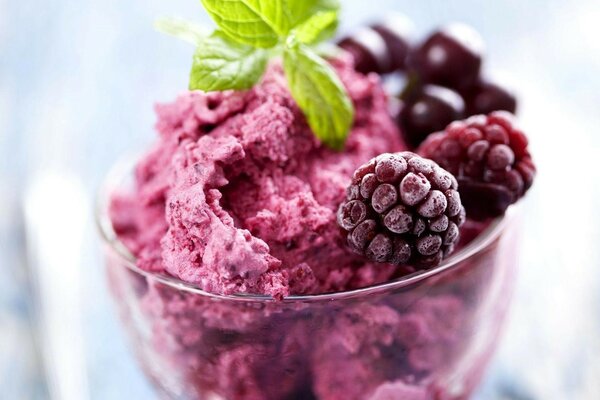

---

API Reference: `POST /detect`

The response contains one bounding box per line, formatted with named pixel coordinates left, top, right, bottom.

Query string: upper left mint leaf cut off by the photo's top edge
left=201, top=0, right=282, bottom=48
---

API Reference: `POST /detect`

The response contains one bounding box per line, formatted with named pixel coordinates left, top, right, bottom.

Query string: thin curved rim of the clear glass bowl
left=94, top=156, right=514, bottom=303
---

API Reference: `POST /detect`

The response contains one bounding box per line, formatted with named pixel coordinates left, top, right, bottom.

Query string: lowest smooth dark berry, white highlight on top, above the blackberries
left=397, top=85, right=465, bottom=148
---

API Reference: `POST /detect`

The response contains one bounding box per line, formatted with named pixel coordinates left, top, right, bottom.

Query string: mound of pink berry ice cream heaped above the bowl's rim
left=112, top=60, right=404, bottom=298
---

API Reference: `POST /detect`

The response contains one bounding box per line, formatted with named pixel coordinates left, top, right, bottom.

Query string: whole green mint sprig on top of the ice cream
left=161, top=0, right=354, bottom=150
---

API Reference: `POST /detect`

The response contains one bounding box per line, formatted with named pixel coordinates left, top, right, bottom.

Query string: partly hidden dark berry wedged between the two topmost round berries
left=371, top=14, right=413, bottom=73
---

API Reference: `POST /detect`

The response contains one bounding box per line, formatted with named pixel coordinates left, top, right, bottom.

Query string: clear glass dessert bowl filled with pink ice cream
left=97, top=161, right=518, bottom=400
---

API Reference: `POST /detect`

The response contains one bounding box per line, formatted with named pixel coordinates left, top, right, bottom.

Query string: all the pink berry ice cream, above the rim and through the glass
left=108, top=51, right=512, bottom=400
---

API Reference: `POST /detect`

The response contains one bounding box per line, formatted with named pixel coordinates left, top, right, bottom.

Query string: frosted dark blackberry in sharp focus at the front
left=337, top=152, right=465, bottom=269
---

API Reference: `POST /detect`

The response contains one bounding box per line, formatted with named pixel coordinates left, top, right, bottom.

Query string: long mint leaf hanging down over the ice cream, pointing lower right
left=283, top=43, right=354, bottom=150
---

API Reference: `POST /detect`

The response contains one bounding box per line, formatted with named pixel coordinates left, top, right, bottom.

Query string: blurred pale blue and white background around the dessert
left=0, top=0, right=600, bottom=400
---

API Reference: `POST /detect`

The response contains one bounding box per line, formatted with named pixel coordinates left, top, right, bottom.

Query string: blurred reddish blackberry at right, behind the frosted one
left=418, top=111, right=536, bottom=219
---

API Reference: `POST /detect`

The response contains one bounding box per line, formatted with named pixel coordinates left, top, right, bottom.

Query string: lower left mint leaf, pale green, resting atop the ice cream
left=189, top=31, right=268, bottom=92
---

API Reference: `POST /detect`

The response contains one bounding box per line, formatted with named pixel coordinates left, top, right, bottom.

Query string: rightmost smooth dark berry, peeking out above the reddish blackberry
left=464, top=77, right=517, bottom=115
